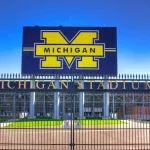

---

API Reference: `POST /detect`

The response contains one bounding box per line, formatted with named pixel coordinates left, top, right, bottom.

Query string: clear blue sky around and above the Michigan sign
left=0, top=0, right=150, bottom=74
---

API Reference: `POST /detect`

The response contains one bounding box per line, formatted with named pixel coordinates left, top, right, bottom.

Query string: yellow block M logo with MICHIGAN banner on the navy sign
left=34, top=30, right=104, bottom=69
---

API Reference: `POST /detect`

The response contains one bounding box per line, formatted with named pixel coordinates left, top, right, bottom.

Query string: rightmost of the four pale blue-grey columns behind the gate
left=103, top=80, right=109, bottom=118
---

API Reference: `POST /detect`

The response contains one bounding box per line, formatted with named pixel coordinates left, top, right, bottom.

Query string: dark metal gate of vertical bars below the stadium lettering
left=0, top=90, right=150, bottom=150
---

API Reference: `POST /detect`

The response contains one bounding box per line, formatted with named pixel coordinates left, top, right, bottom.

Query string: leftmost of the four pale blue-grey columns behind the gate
left=29, top=80, right=35, bottom=118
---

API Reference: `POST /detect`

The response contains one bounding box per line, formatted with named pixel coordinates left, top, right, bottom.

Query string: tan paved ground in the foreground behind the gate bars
left=0, top=121, right=150, bottom=150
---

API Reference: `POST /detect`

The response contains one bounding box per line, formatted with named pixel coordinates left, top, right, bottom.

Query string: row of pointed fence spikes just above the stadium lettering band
left=0, top=73, right=150, bottom=80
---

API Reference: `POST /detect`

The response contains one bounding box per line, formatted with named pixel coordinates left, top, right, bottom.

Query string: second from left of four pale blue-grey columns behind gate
left=54, top=77, right=60, bottom=119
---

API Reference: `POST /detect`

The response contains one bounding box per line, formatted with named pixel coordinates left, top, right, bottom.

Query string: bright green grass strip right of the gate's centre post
left=80, top=119, right=127, bottom=125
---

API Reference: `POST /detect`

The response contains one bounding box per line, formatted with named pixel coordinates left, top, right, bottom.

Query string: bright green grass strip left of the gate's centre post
left=7, top=119, right=63, bottom=128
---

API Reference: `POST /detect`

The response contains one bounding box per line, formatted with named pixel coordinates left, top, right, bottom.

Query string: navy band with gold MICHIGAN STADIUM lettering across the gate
left=0, top=80, right=150, bottom=90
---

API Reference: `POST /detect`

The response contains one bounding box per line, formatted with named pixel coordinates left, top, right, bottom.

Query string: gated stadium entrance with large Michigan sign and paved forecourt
left=0, top=26, right=150, bottom=150
